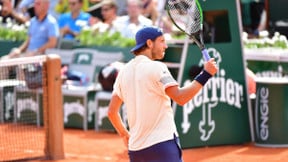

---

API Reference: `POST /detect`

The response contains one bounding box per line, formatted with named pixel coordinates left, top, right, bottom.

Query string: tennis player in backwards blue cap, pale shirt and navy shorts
left=108, top=27, right=217, bottom=162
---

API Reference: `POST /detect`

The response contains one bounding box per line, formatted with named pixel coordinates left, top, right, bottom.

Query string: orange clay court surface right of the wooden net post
left=38, top=129, right=288, bottom=162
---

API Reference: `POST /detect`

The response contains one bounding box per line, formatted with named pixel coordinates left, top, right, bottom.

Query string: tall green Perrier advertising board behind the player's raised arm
left=175, top=0, right=253, bottom=148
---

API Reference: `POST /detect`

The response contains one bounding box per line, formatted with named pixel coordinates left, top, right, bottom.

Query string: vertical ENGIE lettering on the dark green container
left=255, top=87, right=269, bottom=141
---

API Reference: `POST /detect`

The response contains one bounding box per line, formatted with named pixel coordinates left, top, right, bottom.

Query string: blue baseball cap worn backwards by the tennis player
left=130, top=26, right=163, bottom=52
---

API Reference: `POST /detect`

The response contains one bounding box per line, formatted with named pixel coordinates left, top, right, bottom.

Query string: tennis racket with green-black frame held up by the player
left=166, top=0, right=210, bottom=61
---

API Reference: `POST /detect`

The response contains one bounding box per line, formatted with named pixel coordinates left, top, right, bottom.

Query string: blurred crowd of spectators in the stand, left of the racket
left=0, top=0, right=171, bottom=59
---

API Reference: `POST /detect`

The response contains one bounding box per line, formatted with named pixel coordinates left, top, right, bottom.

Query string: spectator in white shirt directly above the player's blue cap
left=115, top=0, right=153, bottom=38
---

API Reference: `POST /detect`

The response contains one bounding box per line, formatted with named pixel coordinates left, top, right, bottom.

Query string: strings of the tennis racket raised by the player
left=167, top=0, right=202, bottom=35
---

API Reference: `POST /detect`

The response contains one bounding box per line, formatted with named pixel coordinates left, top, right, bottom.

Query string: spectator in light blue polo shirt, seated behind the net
left=4, top=0, right=59, bottom=58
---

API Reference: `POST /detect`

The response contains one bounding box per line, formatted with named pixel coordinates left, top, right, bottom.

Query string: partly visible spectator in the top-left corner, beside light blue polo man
left=0, top=0, right=29, bottom=24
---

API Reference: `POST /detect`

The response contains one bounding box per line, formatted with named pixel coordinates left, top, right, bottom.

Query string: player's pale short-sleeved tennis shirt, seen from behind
left=113, top=55, right=178, bottom=151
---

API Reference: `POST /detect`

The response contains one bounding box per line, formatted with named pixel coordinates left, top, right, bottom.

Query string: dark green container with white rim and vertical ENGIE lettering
left=253, top=77, right=288, bottom=147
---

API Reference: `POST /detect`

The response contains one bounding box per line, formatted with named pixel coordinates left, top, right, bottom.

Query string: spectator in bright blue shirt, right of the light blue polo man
left=58, top=0, right=92, bottom=40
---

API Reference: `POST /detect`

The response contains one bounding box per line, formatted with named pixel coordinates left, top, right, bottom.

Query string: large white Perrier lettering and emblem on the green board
left=181, top=48, right=244, bottom=141
